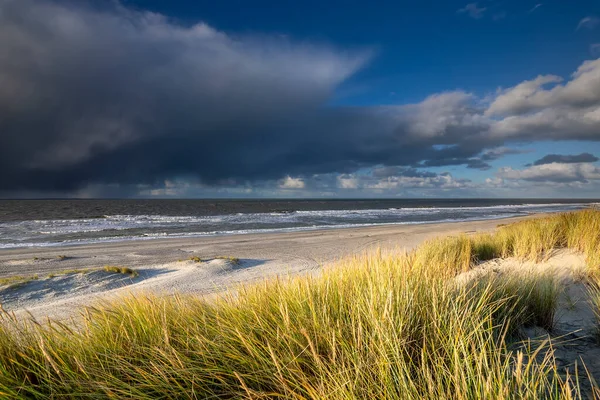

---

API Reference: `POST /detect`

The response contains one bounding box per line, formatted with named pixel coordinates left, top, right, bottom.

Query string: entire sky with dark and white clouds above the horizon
left=0, top=0, right=600, bottom=198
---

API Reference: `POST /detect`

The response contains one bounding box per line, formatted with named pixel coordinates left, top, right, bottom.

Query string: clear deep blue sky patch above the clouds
left=120, top=0, right=600, bottom=105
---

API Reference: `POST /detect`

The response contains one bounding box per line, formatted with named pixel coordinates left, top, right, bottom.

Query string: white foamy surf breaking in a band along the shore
left=0, top=203, right=590, bottom=248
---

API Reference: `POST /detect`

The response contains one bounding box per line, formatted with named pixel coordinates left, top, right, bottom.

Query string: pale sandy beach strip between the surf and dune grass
left=0, top=214, right=540, bottom=319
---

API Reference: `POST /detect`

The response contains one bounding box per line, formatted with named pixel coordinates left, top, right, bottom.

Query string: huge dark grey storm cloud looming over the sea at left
left=0, top=0, right=502, bottom=191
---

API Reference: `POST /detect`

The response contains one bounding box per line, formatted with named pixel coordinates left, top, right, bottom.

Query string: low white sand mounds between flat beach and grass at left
left=0, top=259, right=248, bottom=320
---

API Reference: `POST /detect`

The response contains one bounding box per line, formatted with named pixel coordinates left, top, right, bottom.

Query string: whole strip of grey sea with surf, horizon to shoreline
left=0, top=199, right=596, bottom=249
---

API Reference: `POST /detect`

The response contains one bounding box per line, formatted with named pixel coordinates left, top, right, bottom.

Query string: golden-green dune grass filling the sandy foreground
left=0, top=211, right=600, bottom=399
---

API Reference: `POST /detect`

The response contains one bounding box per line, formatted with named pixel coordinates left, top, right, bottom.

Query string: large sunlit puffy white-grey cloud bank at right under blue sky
left=380, top=59, right=600, bottom=148
